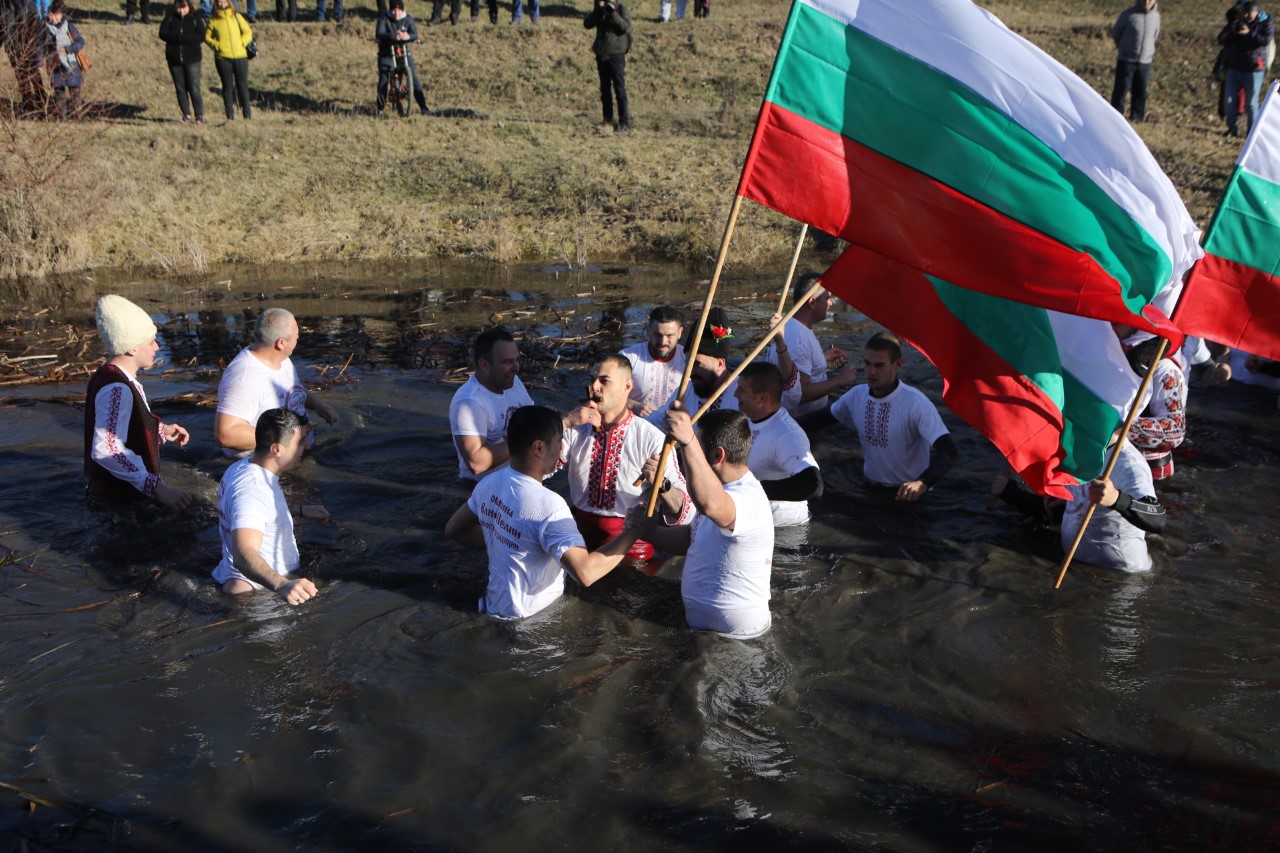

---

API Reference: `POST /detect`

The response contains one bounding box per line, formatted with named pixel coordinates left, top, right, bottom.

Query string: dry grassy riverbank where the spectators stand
left=0, top=0, right=1259, bottom=275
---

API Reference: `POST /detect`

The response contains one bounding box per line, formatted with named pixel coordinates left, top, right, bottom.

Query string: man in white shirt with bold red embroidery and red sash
left=561, top=355, right=694, bottom=548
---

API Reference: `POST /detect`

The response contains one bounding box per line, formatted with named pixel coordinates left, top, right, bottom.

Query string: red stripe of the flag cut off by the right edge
left=1174, top=255, right=1280, bottom=361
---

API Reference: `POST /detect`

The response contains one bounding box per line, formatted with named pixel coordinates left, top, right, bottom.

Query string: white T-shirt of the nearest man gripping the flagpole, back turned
left=680, top=471, right=773, bottom=639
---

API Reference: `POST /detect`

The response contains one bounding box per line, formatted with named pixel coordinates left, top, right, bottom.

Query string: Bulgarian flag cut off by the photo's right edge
left=1175, top=83, right=1280, bottom=360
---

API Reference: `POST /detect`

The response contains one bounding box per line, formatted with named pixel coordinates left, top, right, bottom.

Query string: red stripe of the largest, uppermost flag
left=737, top=102, right=1169, bottom=337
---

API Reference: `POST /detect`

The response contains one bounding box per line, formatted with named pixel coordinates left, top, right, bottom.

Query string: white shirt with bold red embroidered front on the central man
left=561, top=410, right=694, bottom=524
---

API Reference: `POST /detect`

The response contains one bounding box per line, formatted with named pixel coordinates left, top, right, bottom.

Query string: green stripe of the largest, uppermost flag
left=765, top=3, right=1172, bottom=311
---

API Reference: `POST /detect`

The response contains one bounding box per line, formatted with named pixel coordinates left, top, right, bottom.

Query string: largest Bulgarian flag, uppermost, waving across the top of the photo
left=737, top=0, right=1202, bottom=337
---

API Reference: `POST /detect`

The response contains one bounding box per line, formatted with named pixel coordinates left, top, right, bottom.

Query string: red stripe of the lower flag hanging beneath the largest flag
left=822, top=246, right=1079, bottom=500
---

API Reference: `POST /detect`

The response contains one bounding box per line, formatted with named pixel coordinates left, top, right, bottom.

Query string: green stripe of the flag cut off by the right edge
left=1204, top=168, right=1280, bottom=275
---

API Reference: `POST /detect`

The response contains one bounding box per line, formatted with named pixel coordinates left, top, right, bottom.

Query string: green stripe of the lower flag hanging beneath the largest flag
left=929, top=277, right=1123, bottom=480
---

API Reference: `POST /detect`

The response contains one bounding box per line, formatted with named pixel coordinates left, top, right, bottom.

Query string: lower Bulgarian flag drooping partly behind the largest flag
left=823, top=246, right=1142, bottom=500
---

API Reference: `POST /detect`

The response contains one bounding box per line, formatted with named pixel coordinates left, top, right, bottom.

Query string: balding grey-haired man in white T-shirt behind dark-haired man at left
left=214, top=307, right=338, bottom=456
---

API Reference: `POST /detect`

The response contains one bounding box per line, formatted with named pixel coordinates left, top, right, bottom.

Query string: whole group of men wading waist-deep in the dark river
left=84, top=274, right=1249, bottom=630
